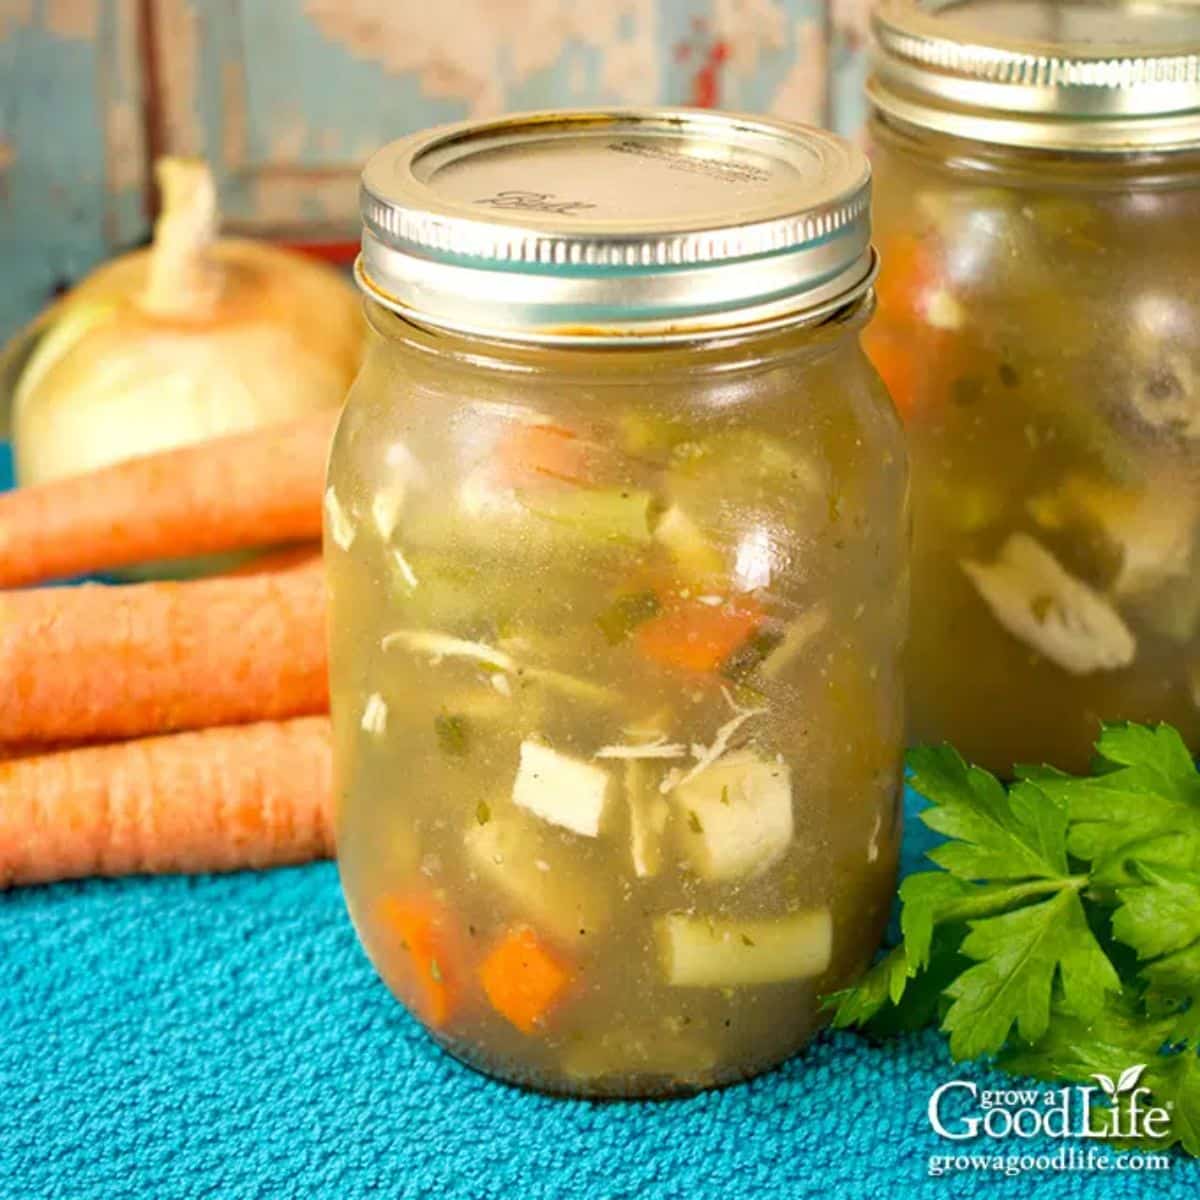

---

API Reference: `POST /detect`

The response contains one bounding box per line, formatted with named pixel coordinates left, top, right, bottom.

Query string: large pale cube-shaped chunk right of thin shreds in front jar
left=671, top=750, right=794, bottom=880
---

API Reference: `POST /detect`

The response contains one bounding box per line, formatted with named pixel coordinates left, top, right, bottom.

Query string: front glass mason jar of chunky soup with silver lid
left=326, top=112, right=907, bottom=1096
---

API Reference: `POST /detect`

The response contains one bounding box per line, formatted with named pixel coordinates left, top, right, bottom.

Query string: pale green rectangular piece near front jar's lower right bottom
left=655, top=908, right=833, bottom=988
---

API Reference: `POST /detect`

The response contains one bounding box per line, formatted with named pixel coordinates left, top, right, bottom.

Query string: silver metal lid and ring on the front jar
left=356, top=109, right=875, bottom=341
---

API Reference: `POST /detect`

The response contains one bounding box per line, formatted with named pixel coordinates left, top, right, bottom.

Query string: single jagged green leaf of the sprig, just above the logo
left=942, top=888, right=1121, bottom=1058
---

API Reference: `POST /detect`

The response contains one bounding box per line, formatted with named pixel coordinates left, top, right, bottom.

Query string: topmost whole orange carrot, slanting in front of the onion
left=0, top=413, right=337, bottom=588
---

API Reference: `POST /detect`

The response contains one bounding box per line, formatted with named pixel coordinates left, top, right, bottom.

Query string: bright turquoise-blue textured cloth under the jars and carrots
left=0, top=444, right=1200, bottom=1200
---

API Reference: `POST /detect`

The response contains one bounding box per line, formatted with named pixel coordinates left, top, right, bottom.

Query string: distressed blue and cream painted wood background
left=0, top=0, right=868, bottom=340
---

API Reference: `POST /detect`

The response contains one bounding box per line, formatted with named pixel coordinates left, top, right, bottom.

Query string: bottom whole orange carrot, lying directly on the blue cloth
left=0, top=716, right=334, bottom=888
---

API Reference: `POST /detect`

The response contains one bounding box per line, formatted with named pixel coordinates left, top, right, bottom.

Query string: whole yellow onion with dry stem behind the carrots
left=10, top=158, right=364, bottom=484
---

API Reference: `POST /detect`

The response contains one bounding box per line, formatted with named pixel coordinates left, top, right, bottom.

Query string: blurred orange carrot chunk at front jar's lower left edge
left=378, top=893, right=466, bottom=1030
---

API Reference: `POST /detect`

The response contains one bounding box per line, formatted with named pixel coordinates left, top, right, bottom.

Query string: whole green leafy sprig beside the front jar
left=830, top=724, right=1200, bottom=1154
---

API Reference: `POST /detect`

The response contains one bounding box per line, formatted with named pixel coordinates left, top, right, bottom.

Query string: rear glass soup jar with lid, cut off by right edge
left=866, top=0, right=1200, bottom=772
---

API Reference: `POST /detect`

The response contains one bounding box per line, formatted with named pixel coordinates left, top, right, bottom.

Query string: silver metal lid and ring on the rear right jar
left=868, top=0, right=1200, bottom=154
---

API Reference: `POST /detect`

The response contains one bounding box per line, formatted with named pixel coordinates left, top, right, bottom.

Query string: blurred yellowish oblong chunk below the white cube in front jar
left=464, top=805, right=611, bottom=943
